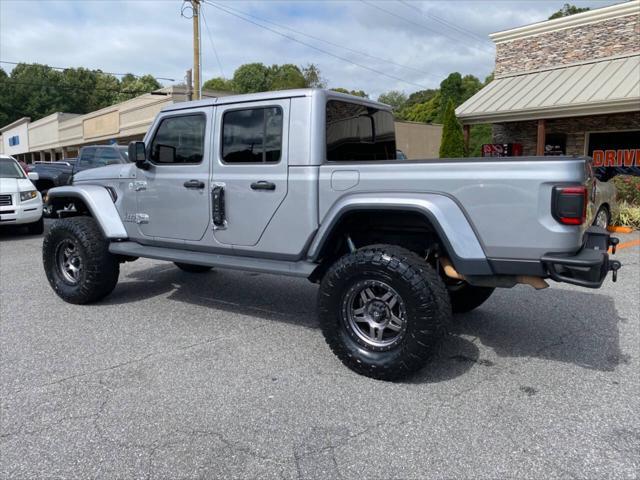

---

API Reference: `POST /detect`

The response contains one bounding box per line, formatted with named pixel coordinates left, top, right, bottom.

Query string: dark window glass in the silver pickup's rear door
left=222, top=107, right=282, bottom=163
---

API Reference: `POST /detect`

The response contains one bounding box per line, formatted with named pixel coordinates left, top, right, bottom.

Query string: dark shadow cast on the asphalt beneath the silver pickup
left=103, top=264, right=628, bottom=382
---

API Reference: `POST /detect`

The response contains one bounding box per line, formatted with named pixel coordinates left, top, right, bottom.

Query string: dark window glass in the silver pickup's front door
left=149, top=115, right=207, bottom=164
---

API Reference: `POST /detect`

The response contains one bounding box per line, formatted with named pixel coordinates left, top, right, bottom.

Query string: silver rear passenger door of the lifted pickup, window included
left=212, top=99, right=290, bottom=246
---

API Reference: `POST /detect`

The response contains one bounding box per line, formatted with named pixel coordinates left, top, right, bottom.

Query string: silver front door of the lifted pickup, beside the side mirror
left=137, top=107, right=213, bottom=242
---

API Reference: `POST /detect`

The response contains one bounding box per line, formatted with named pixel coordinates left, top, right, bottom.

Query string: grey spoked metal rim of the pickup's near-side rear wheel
left=344, top=280, right=407, bottom=349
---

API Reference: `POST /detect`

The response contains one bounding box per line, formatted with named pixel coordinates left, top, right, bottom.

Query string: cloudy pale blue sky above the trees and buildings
left=0, top=0, right=620, bottom=98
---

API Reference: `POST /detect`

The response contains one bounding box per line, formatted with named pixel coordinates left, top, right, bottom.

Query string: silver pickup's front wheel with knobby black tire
left=42, top=217, right=120, bottom=304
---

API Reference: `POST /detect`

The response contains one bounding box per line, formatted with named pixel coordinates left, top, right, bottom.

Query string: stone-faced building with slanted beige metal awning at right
left=456, top=0, right=640, bottom=164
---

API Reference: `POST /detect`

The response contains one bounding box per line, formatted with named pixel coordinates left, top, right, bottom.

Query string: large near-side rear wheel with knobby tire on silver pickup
left=318, top=245, right=451, bottom=380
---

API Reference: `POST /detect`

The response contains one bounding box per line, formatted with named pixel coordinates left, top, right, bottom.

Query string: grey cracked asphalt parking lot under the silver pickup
left=0, top=222, right=640, bottom=479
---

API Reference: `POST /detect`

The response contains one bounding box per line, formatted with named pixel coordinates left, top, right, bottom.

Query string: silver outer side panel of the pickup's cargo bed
left=319, top=156, right=590, bottom=260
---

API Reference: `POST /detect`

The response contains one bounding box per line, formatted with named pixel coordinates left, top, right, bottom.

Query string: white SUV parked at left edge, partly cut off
left=0, top=155, right=44, bottom=234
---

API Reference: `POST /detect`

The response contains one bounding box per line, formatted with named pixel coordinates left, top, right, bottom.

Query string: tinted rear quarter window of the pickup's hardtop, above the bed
left=326, top=100, right=396, bottom=162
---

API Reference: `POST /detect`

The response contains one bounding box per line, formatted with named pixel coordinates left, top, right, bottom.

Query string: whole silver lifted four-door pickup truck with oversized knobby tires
left=43, top=90, right=620, bottom=380
